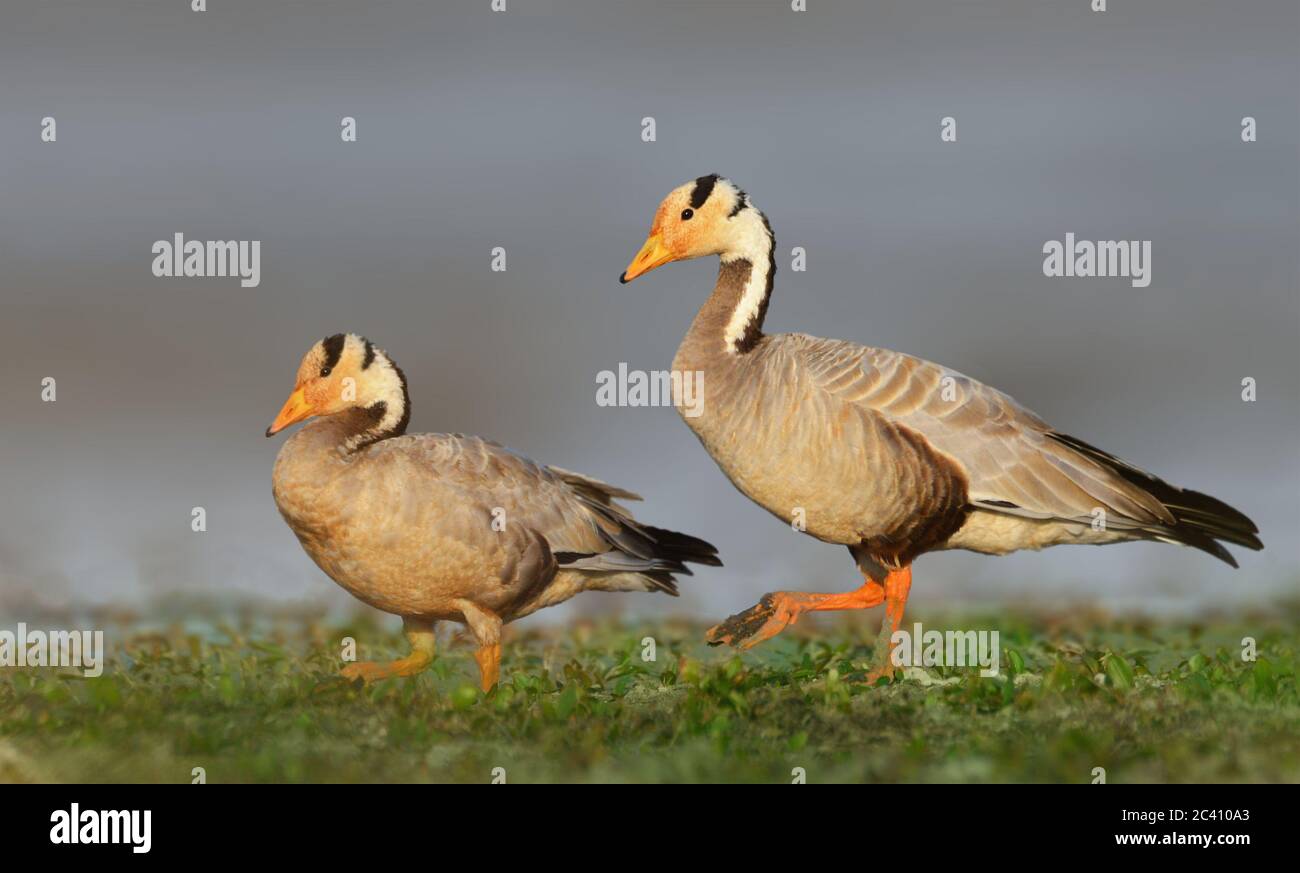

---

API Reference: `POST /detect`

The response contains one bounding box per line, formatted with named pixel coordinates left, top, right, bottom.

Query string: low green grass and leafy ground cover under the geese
left=0, top=611, right=1300, bottom=783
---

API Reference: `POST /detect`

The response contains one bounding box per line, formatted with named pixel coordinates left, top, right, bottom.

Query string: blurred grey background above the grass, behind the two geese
left=0, top=0, right=1300, bottom=621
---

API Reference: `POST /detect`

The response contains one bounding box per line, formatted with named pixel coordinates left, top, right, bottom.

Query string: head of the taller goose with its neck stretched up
left=619, top=173, right=772, bottom=285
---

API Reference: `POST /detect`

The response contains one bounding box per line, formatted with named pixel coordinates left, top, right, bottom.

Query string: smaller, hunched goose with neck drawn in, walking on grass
left=267, top=334, right=722, bottom=691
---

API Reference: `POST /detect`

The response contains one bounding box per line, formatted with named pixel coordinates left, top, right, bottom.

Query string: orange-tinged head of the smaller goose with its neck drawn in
left=267, top=334, right=410, bottom=442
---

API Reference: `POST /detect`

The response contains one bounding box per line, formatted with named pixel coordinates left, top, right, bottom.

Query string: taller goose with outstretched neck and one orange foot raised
left=620, top=175, right=1262, bottom=674
